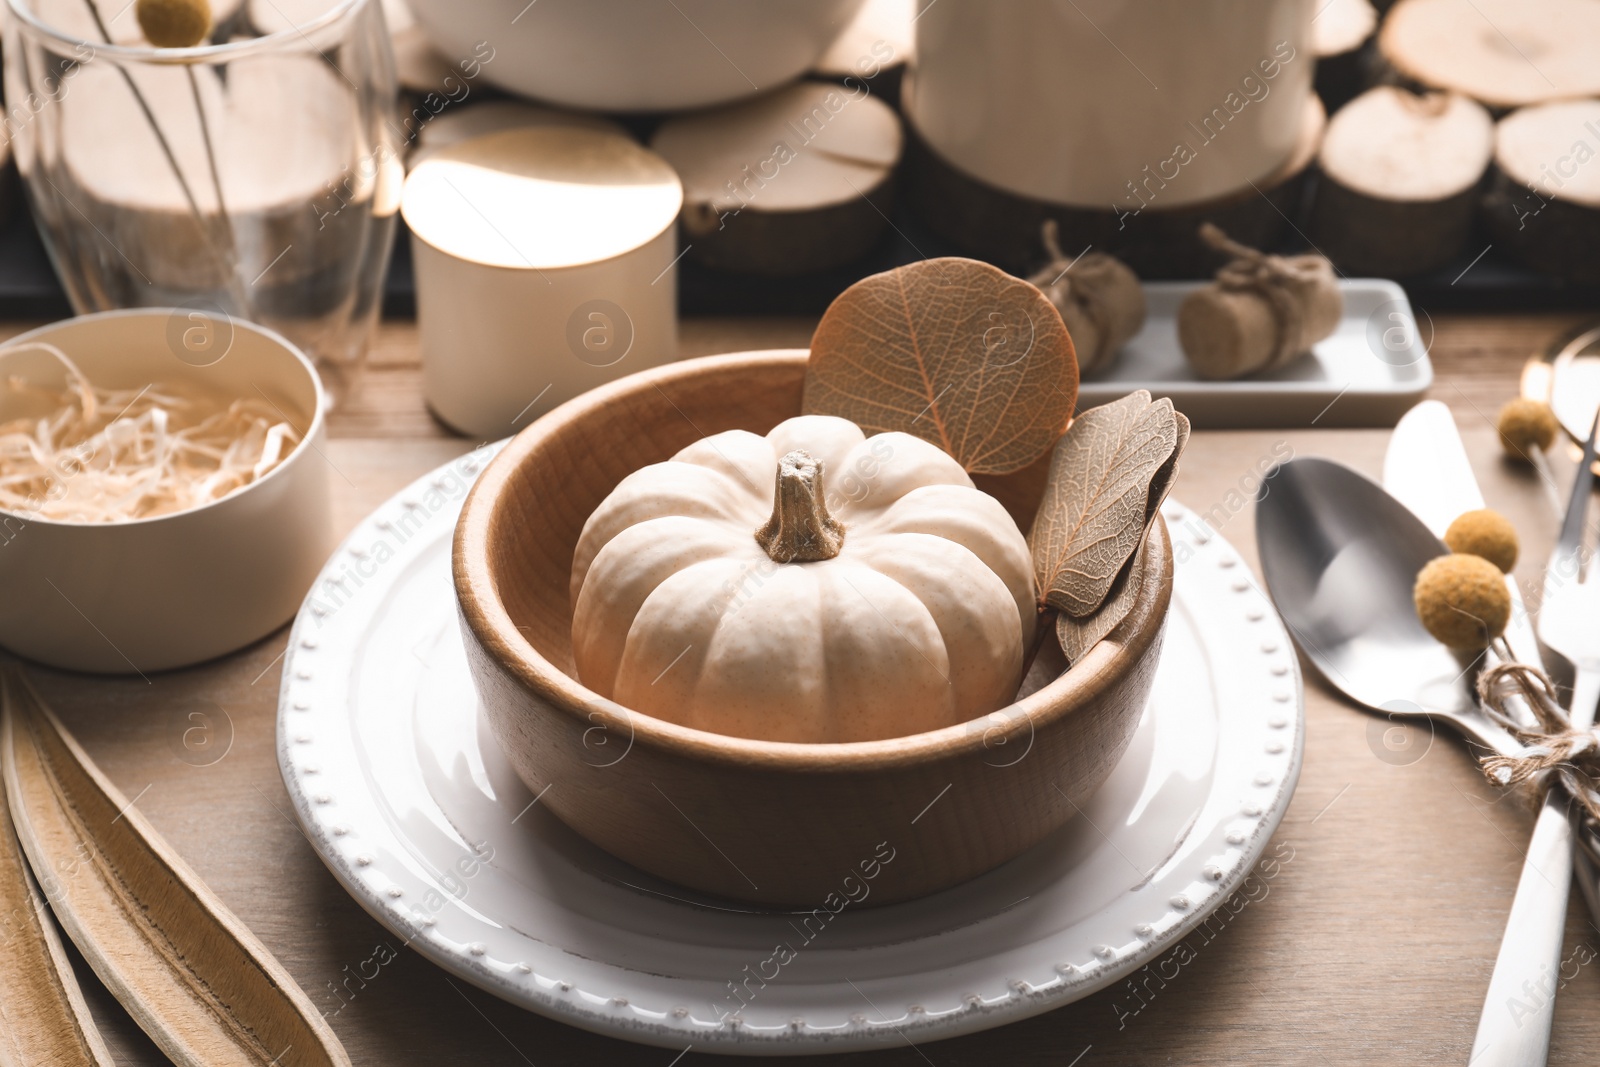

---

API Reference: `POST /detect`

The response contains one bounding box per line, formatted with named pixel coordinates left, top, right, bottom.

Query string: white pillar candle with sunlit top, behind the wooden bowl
left=402, top=126, right=683, bottom=440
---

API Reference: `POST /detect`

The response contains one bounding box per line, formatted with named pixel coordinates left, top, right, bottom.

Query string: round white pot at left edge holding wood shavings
left=0, top=309, right=333, bottom=673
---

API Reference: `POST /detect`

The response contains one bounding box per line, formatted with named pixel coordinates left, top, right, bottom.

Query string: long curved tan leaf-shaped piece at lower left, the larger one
left=0, top=670, right=350, bottom=1067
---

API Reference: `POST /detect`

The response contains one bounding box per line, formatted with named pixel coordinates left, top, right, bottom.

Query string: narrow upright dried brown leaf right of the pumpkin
left=1029, top=389, right=1187, bottom=619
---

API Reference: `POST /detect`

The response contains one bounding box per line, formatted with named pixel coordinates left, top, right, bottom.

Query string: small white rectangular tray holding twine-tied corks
left=1078, top=278, right=1434, bottom=429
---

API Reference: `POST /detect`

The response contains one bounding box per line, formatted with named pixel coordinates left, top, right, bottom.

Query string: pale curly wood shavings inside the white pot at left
left=0, top=342, right=301, bottom=523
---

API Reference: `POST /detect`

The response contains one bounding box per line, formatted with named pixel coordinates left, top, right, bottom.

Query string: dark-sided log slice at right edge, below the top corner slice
left=1483, top=101, right=1600, bottom=283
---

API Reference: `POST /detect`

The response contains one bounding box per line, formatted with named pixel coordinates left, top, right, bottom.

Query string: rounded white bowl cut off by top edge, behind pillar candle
left=410, top=0, right=862, bottom=110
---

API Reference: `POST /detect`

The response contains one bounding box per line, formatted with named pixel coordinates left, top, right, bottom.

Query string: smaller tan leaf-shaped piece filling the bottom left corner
left=0, top=755, right=115, bottom=1067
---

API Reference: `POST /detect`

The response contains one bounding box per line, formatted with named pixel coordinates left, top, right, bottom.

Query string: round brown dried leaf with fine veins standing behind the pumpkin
left=803, top=258, right=1078, bottom=474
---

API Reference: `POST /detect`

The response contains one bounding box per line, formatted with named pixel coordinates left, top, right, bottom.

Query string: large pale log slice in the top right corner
left=1378, top=0, right=1600, bottom=109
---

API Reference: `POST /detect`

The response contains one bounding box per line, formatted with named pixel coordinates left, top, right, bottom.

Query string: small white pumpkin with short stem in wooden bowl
left=571, top=416, right=1035, bottom=742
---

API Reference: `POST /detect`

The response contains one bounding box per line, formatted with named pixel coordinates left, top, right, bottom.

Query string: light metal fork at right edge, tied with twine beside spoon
left=1467, top=413, right=1600, bottom=1067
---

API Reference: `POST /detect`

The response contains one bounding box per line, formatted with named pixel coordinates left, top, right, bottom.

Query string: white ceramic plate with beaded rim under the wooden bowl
left=278, top=446, right=1302, bottom=1054
